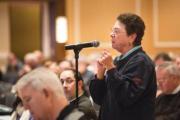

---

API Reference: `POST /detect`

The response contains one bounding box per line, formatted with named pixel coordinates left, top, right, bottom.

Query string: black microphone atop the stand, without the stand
left=65, top=40, right=100, bottom=50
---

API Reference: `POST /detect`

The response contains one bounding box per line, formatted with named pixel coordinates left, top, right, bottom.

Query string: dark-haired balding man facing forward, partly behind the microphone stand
left=60, top=69, right=97, bottom=120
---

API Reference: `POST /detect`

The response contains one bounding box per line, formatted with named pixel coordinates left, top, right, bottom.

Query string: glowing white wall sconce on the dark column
left=56, top=16, right=68, bottom=43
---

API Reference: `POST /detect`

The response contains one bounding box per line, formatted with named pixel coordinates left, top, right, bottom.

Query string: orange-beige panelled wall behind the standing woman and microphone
left=66, top=0, right=180, bottom=57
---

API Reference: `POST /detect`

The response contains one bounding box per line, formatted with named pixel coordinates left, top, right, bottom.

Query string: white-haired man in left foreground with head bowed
left=15, top=67, right=87, bottom=120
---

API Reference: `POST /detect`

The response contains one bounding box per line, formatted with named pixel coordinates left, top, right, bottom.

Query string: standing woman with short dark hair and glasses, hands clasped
left=90, top=13, right=157, bottom=120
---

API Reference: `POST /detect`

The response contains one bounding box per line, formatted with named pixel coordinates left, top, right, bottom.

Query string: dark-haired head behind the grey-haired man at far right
left=154, top=52, right=172, bottom=66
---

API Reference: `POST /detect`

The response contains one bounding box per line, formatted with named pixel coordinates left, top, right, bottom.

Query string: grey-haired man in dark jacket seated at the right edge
left=155, top=62, right=180, bottom=120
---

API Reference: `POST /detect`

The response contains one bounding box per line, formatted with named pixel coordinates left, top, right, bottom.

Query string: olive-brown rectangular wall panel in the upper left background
left=9, top=2, right=41, bottom=59
